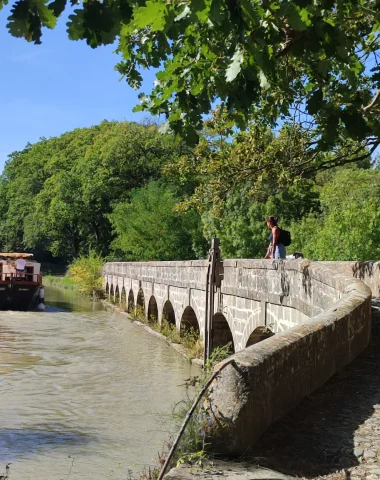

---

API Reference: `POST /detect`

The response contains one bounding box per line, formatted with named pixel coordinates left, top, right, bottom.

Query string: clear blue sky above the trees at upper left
left=0, top=8, right=155, bottom=172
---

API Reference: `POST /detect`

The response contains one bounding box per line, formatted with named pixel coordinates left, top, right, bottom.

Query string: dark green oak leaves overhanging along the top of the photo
left=0, top=0, right=380, bottom=150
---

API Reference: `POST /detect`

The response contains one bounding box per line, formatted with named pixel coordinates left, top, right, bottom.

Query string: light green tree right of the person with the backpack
left=292, top=169, right=380, bottom=260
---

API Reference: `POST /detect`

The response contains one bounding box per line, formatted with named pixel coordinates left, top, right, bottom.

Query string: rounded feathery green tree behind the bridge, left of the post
left=109, top=181, right=206, bottom=261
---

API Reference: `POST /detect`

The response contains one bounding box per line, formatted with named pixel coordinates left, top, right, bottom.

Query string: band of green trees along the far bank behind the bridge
left=0, top=118, right=380, bottom=264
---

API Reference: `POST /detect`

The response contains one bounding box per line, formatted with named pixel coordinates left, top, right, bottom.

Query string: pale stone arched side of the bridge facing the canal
left=104, top=260, right=326, bottom=352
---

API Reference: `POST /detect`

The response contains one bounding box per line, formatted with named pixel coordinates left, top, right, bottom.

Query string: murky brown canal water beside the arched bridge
left=0, top=288, right=197, bottom=480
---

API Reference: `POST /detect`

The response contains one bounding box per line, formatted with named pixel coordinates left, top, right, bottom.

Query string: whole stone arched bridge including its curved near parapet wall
left=103, top=260, right=380, bottom=454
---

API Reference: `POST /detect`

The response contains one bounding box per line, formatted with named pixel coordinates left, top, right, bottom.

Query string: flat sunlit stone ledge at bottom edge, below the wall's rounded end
left=164, top=460, right=293, bottom=480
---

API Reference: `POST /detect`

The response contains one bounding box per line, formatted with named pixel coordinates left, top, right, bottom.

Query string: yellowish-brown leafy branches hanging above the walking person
left=165, top=118, right=332, bottom=212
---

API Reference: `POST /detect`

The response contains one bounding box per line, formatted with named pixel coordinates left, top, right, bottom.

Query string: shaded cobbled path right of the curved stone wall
left=250, top=299, right=380, bottom=480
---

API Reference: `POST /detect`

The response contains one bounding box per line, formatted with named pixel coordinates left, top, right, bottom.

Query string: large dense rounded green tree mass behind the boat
left=0, top=122, right=202, bottom=259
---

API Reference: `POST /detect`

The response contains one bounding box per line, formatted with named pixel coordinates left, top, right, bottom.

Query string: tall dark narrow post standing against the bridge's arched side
left=203, top=237, right=222, bottom=366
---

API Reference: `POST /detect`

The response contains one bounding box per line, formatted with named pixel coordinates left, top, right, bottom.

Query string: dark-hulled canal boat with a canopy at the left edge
left=0, top=253, right=45, bottom=310
